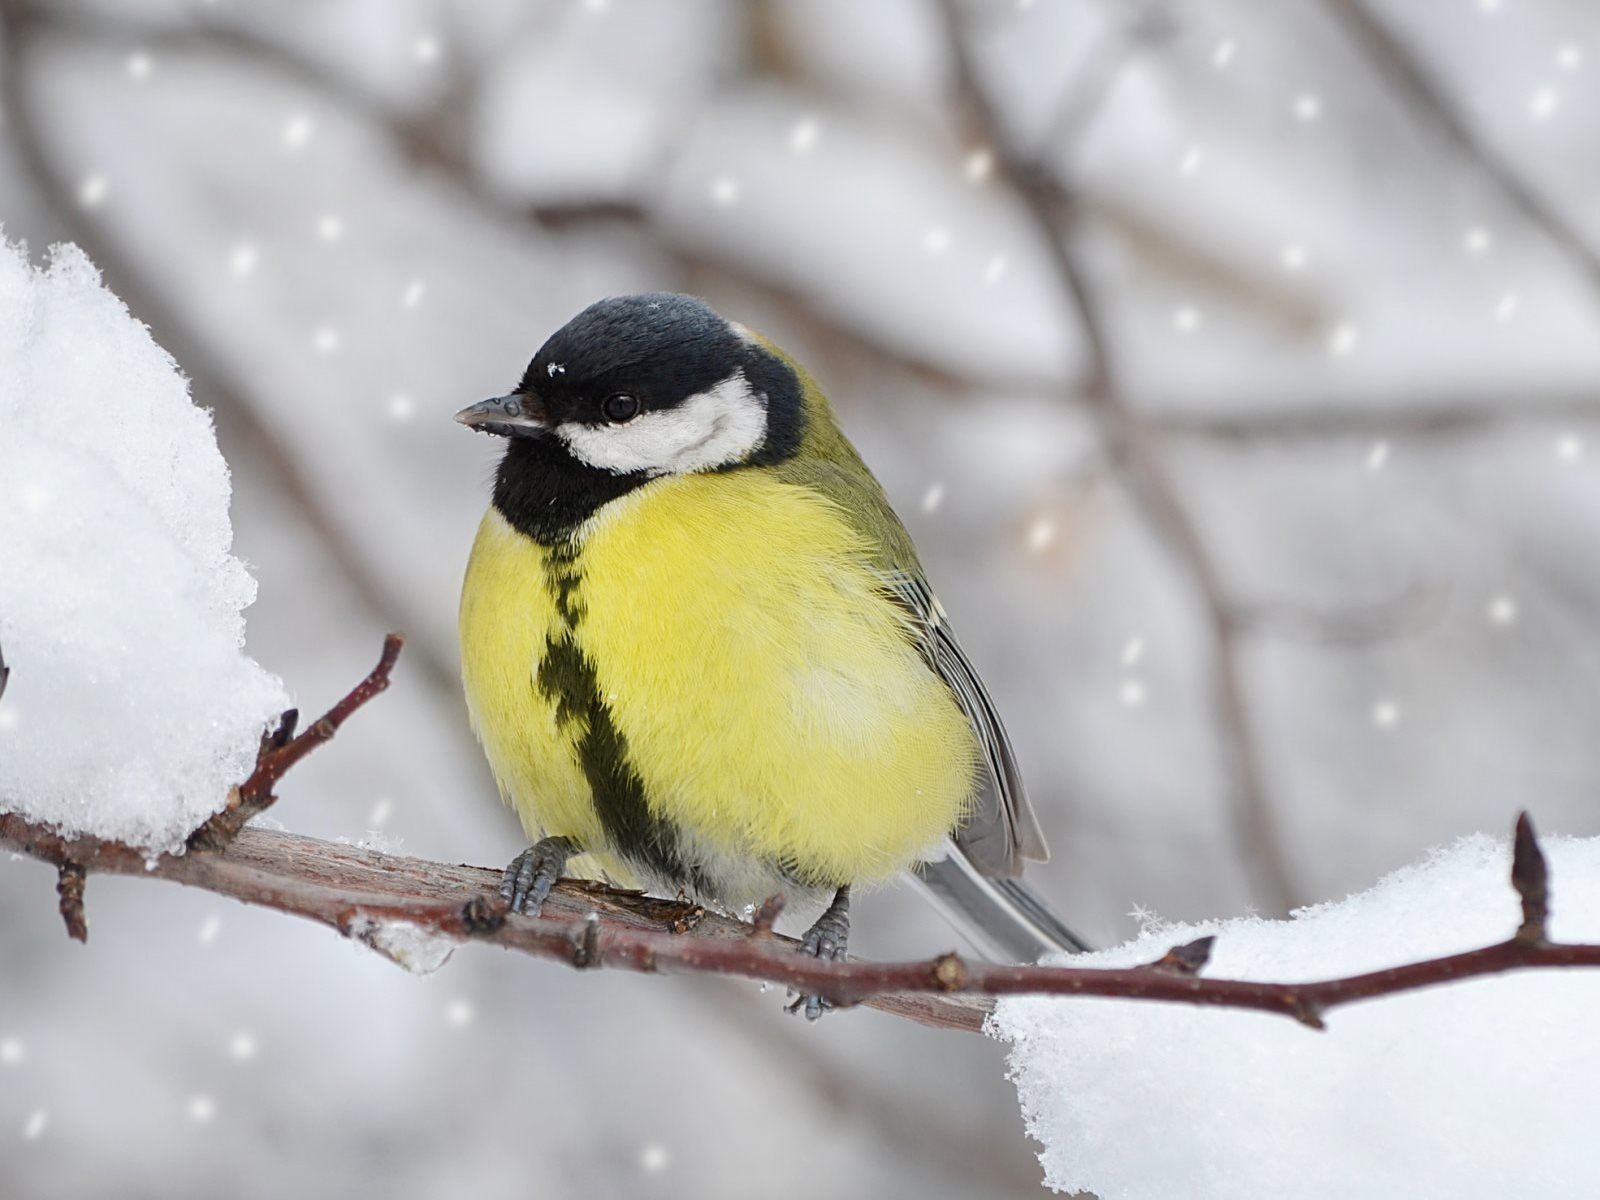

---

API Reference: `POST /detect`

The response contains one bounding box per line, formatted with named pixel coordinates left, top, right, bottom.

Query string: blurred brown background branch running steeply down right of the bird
left=941, top=0, right=1296, bottom=912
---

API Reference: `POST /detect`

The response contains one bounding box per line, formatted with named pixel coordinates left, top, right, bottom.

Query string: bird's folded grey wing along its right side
left=885, top=570, right=1050, bottom=878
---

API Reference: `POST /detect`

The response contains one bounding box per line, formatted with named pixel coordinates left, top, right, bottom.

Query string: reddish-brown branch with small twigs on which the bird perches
left=0, top=635, right=1600, bottom=1030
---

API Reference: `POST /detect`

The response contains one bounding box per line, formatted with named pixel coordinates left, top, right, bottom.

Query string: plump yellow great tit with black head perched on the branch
left=456, top=293, right=1086, bottom=1019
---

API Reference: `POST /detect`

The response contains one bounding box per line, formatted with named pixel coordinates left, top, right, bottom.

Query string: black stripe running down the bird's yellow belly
left=534, top=539, right=707, bottom=891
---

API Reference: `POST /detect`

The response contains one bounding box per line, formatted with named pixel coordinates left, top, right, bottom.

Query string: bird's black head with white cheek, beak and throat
left=456, top=291, right=805, bottom=541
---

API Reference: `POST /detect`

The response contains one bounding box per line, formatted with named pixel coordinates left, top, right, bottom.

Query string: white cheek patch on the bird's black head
left=555, top=371, right=766, bottom=475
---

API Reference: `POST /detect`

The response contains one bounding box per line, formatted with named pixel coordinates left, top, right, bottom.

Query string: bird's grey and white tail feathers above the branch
left=912, top=846, right=1090, bottom=963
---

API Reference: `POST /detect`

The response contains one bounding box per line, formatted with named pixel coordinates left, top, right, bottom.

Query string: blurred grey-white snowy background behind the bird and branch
left=0, top=0, right=1600, bottom=1200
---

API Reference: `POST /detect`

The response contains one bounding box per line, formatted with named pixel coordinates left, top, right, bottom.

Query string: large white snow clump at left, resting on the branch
left=0, top=242, right=288, bottom=851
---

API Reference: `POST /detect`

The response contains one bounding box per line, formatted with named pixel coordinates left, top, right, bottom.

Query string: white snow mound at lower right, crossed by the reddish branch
left=992, top=835, right=1600, bottom=1200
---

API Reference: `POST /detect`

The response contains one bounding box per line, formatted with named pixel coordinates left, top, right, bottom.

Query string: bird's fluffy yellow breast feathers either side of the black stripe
left=461, top=470, right=978, bottom=885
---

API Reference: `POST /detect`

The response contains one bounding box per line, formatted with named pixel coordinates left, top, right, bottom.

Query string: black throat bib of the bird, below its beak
left=494, top=437, right=651, bottom=546
